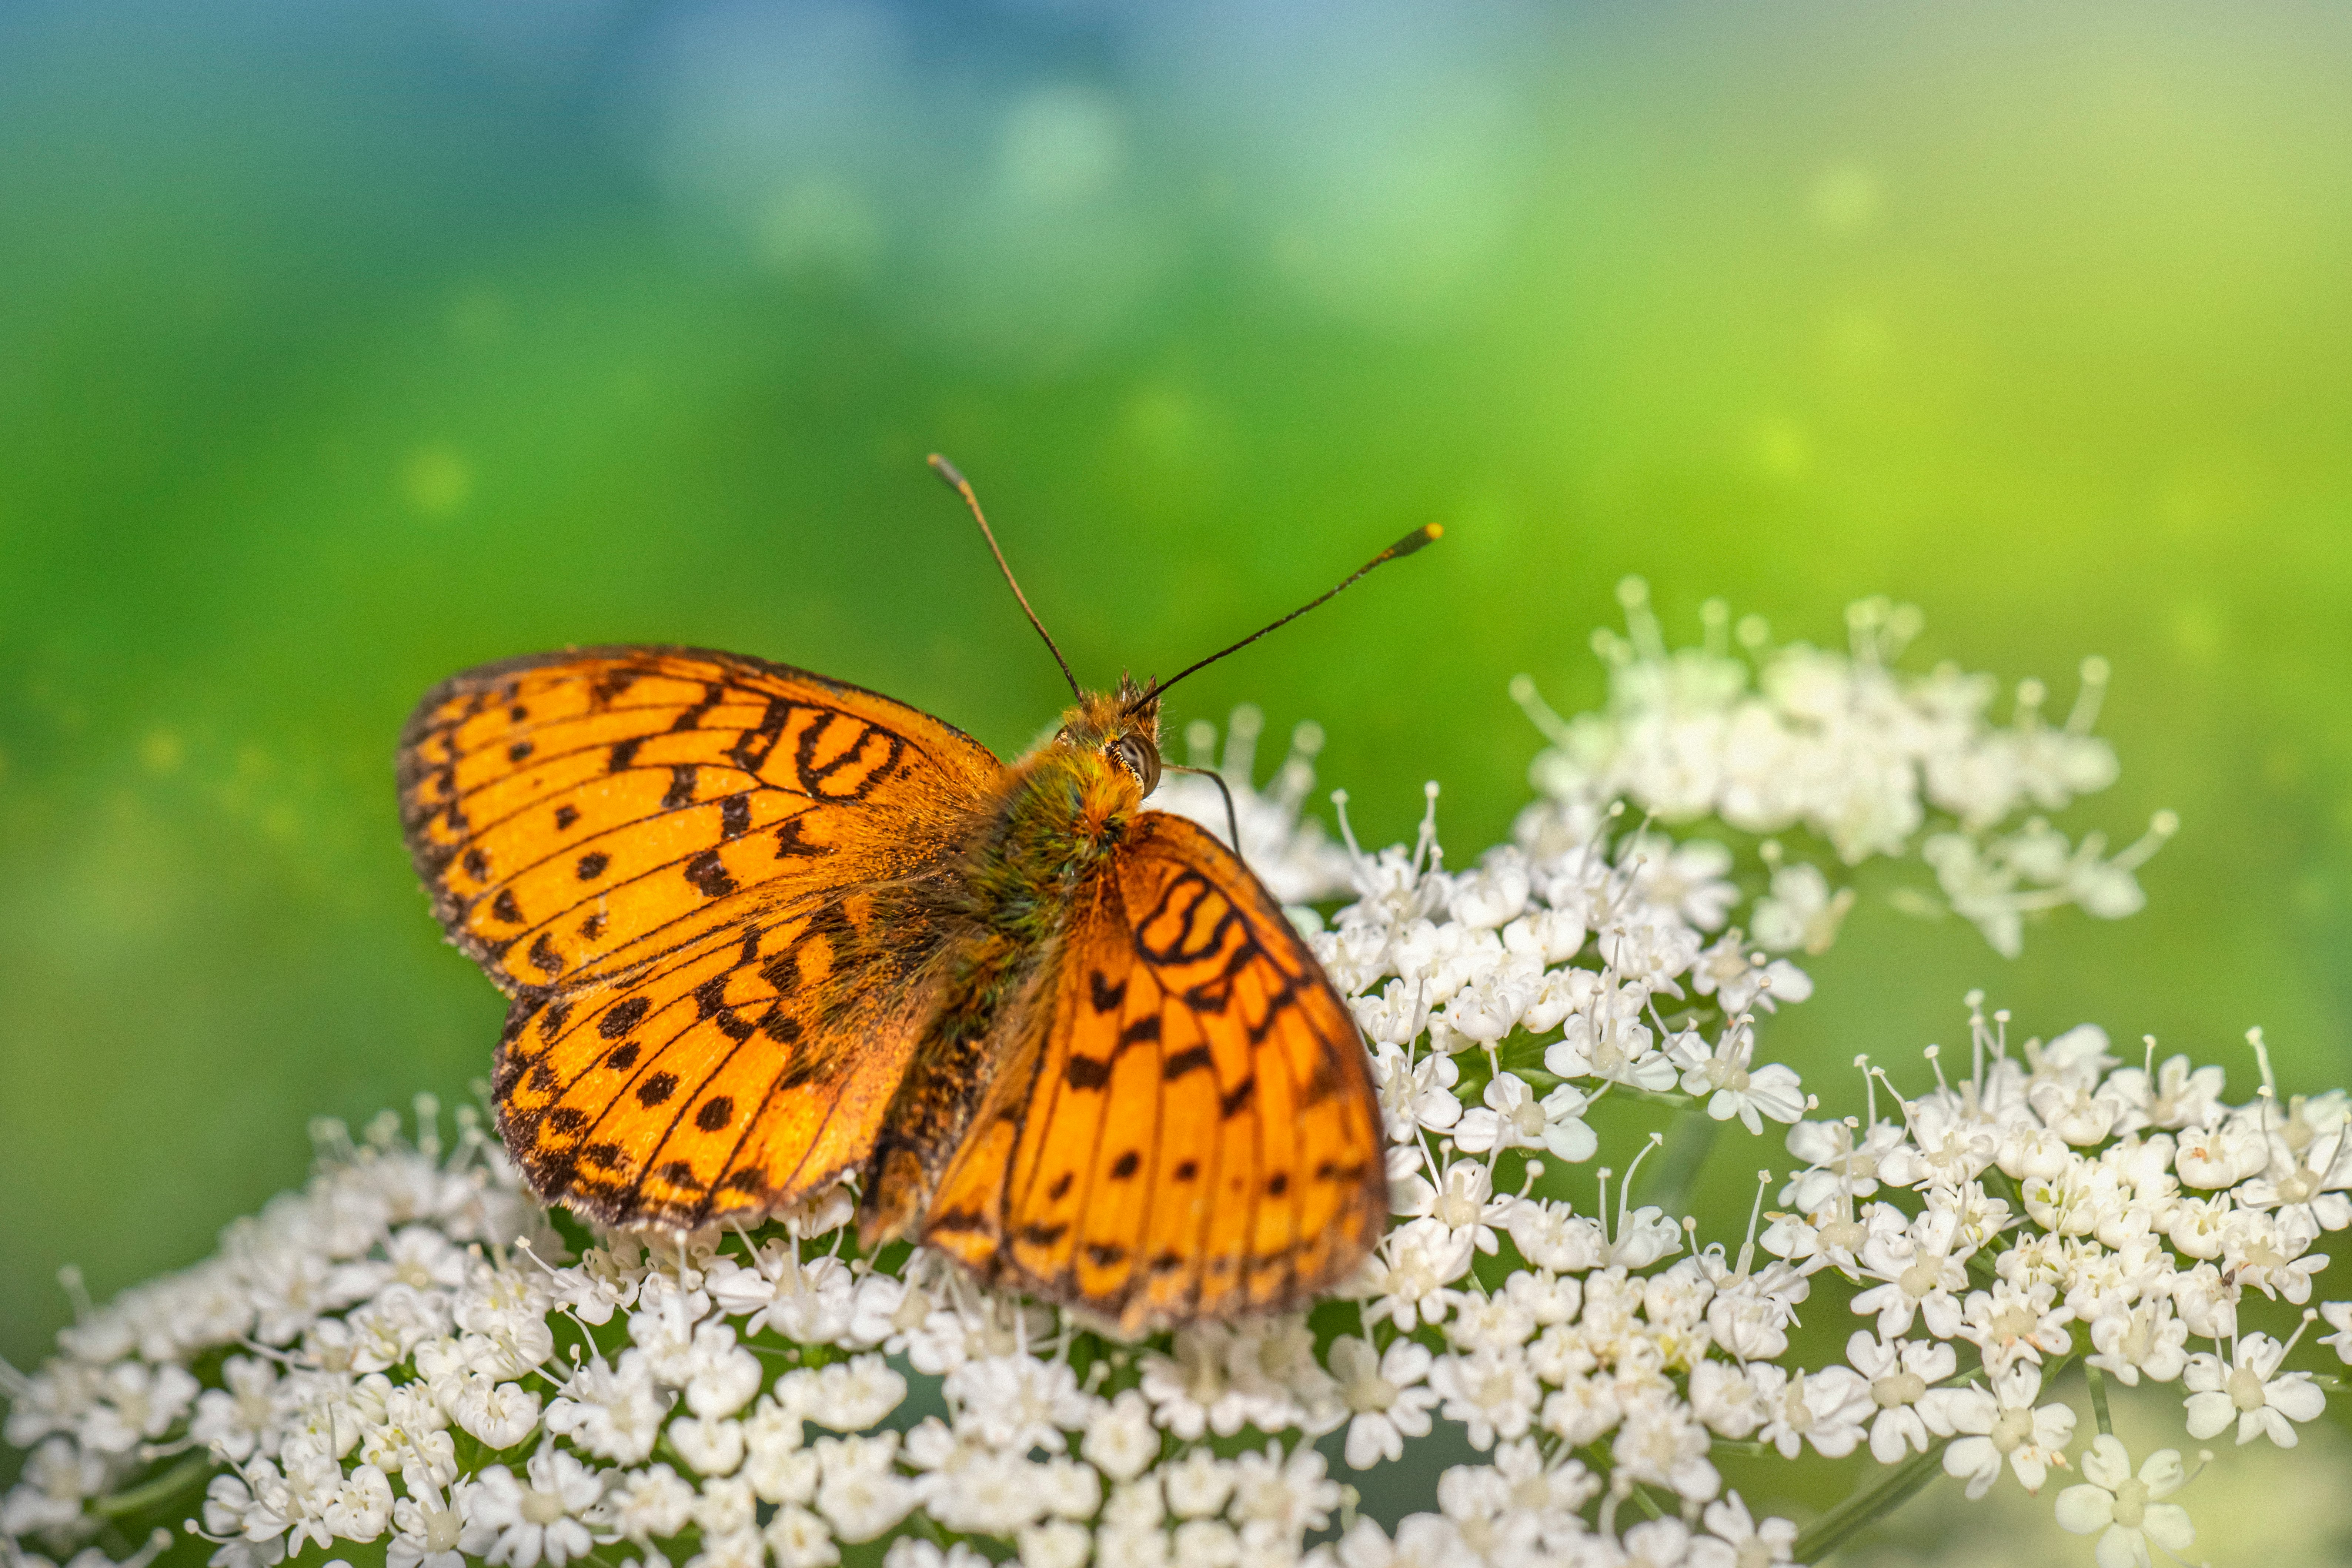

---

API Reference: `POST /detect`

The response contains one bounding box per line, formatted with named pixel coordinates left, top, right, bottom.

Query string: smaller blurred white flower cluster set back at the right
left=1512, top=578, right=2178, bottom=957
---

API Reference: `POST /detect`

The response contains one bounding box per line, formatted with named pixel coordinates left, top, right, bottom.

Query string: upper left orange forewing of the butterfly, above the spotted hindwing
left=400, top=649, right=1004, bottom=994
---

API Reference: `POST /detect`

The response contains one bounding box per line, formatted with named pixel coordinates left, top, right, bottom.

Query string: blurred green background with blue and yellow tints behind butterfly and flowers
left=0, top=0, right=2352, bottom=1457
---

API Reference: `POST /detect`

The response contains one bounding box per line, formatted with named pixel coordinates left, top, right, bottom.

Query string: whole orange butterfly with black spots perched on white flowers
left=400, top=458, right=1437, bottom=1331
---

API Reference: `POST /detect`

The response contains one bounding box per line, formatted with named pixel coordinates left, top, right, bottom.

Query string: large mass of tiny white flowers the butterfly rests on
left=0, top=592, right=2352, bottom=1568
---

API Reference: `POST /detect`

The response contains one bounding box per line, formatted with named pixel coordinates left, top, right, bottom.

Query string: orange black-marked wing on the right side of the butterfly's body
left=924, top=811, right=1388, bottom=1328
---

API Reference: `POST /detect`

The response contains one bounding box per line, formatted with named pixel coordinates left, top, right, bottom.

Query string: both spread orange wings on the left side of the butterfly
left=400, top=649, right=1004, bottom=1227
